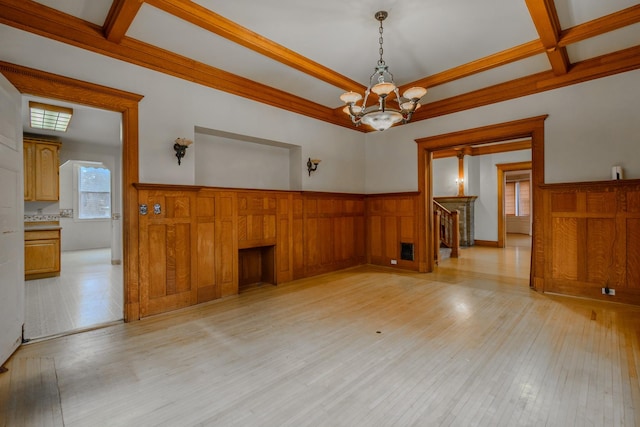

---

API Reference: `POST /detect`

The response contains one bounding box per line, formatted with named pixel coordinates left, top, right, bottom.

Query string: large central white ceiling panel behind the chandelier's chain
left=191, top=0, right=538, bottom=85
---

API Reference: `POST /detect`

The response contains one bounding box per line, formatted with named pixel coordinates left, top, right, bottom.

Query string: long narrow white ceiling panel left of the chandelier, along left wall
left=127, top=5, right=343, bottom=108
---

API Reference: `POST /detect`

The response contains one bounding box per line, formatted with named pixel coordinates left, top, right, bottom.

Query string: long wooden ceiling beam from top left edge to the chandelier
left=146, top=0, right=366, bottom=93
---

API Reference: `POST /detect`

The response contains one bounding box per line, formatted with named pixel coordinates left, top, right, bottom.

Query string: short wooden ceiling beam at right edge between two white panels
left=558, top=4, right=640, bottom=46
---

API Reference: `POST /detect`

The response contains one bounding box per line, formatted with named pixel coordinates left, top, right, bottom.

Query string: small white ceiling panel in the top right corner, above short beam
left=555, top=0, right=638, bottom=29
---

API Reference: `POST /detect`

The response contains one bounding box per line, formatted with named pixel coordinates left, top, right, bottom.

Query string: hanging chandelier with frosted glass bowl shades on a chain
left=340, top=10, right=427, bottom=131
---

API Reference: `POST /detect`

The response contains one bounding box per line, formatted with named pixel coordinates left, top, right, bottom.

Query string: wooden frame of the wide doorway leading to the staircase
left=415, top=115, right=548, bottom=290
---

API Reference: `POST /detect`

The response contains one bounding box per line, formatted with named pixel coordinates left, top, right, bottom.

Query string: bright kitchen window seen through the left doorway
left=77, top=165, right=111, bottom=219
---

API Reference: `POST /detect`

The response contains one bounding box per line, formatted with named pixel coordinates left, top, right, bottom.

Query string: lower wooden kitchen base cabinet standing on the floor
left=24, top=227, right=60, bottom=280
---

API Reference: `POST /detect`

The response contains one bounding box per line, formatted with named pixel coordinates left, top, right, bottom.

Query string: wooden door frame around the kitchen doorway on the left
left=0, top=61, right=143, bottom=322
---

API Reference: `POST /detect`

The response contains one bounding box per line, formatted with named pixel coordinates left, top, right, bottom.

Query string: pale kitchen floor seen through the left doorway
left=24, top=249, right=123, bottom=339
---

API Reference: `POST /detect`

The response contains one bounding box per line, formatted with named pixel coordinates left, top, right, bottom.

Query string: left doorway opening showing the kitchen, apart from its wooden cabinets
left=22, top=95, right=123, bottom=341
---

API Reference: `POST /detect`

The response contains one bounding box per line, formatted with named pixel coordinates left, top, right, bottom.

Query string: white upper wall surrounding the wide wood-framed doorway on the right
left=365, top=70, right=640, bottom=193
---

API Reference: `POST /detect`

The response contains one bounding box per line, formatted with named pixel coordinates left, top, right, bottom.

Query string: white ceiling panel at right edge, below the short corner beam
left=567, top=24, right=640, bottom=63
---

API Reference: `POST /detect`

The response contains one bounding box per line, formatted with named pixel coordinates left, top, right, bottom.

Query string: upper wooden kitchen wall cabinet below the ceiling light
left=23, top=137, right=60, bottom=202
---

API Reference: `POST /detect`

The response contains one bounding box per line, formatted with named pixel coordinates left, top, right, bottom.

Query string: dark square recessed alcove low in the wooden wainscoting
left=238, top=245, right=276, bottom=292
